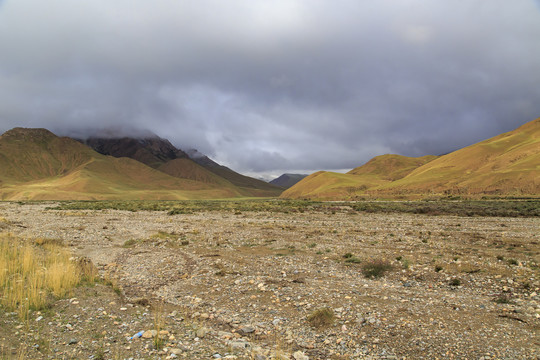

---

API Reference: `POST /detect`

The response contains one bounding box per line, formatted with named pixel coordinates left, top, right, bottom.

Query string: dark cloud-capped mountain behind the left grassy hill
left=80, top=134, right=283, bottom=197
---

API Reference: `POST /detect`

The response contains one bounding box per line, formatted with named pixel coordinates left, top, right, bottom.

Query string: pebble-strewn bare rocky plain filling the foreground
left=0, top=203, right=540, bottom=360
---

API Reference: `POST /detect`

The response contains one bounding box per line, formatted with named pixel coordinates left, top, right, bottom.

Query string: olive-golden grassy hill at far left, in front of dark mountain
left=0, top=128, right=242, bottom=200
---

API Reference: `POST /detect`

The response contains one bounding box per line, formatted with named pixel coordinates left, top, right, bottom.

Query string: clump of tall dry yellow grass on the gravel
left=0, top=234, right=81, bottom=319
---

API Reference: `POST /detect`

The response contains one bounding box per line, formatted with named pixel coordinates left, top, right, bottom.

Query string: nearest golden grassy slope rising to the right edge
left=373, top=119, right=540, bottom=195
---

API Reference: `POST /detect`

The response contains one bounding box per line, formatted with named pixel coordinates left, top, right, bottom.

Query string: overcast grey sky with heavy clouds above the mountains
left=0, top=0, right=540, bottom=176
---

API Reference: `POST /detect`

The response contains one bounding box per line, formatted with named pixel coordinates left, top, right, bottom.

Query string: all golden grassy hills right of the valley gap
left=281, top=119, right=540, bottom=199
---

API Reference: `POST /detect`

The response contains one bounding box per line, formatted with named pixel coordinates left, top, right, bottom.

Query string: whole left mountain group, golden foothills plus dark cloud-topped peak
left=0, top=128, right=283, bottom=200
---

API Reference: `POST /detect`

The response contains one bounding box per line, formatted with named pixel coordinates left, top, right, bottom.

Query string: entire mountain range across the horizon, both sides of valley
left=0, top=118, right=540, bottom=200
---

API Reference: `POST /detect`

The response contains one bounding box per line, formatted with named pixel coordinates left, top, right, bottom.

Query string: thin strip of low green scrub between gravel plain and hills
left=48, top=199, right=540, bottom=217
